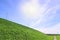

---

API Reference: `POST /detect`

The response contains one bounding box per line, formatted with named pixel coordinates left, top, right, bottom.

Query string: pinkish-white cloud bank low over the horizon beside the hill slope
left=37, top=23, right=60, bottom=34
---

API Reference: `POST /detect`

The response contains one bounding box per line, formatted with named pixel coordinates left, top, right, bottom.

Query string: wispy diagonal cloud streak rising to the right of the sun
left=32, top=1, right=60, bottom=26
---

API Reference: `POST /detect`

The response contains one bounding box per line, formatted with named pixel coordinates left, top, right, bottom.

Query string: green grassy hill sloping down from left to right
left=0, top=18, right=52, bottom=40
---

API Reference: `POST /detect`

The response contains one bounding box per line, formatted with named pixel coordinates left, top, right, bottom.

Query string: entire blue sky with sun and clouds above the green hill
left=0, top=0, right=60, bottom=34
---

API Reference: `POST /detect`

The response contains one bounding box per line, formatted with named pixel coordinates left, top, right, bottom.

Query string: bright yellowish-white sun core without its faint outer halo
left=21, top=3, right=39, bottom=18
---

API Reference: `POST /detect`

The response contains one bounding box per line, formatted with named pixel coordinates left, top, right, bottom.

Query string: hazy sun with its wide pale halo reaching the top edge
left=19, top=0, right=45, bottom=19
